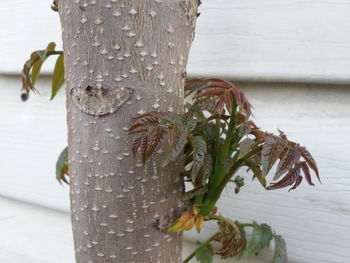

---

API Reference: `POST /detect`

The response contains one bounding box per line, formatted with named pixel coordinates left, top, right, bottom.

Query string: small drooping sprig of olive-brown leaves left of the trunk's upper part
left=22, top=42, right=64, bottom=100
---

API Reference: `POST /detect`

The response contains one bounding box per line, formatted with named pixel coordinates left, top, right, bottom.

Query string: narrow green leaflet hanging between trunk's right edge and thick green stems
left=191, top=136, right=207, bottom=182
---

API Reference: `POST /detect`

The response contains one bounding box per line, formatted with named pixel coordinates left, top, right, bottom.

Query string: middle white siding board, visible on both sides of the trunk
left=0, top=77, right=350, bottom=263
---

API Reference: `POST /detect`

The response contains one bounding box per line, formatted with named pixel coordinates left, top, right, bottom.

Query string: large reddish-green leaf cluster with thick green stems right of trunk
left=129, top=79, right=319, bottom=212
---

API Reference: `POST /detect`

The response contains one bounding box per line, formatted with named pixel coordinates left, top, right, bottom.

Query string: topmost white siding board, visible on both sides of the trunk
left=0, top=0, right=350, bottom=83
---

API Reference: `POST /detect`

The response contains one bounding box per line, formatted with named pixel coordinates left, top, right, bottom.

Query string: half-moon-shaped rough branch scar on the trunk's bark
left=70, top=85, right=133, bottom=116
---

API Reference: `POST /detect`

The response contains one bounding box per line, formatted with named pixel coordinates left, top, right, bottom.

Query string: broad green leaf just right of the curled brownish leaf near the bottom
left=243, top=223, right=273, bottom=258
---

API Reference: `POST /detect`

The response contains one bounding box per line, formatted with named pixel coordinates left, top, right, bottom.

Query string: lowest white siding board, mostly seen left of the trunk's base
left=0, top=197, right=272, bottom=263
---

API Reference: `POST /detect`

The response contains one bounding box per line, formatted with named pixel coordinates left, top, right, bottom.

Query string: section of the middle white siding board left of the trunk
left=0, top=77, right=68, bottom=211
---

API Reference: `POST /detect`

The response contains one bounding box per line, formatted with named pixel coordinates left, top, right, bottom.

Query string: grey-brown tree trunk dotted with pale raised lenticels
left=59, top=0, right=198, bottom=263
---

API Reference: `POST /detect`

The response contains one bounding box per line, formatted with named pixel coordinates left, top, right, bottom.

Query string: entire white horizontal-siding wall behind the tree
left=0, top=0, right=350, bottom=263
